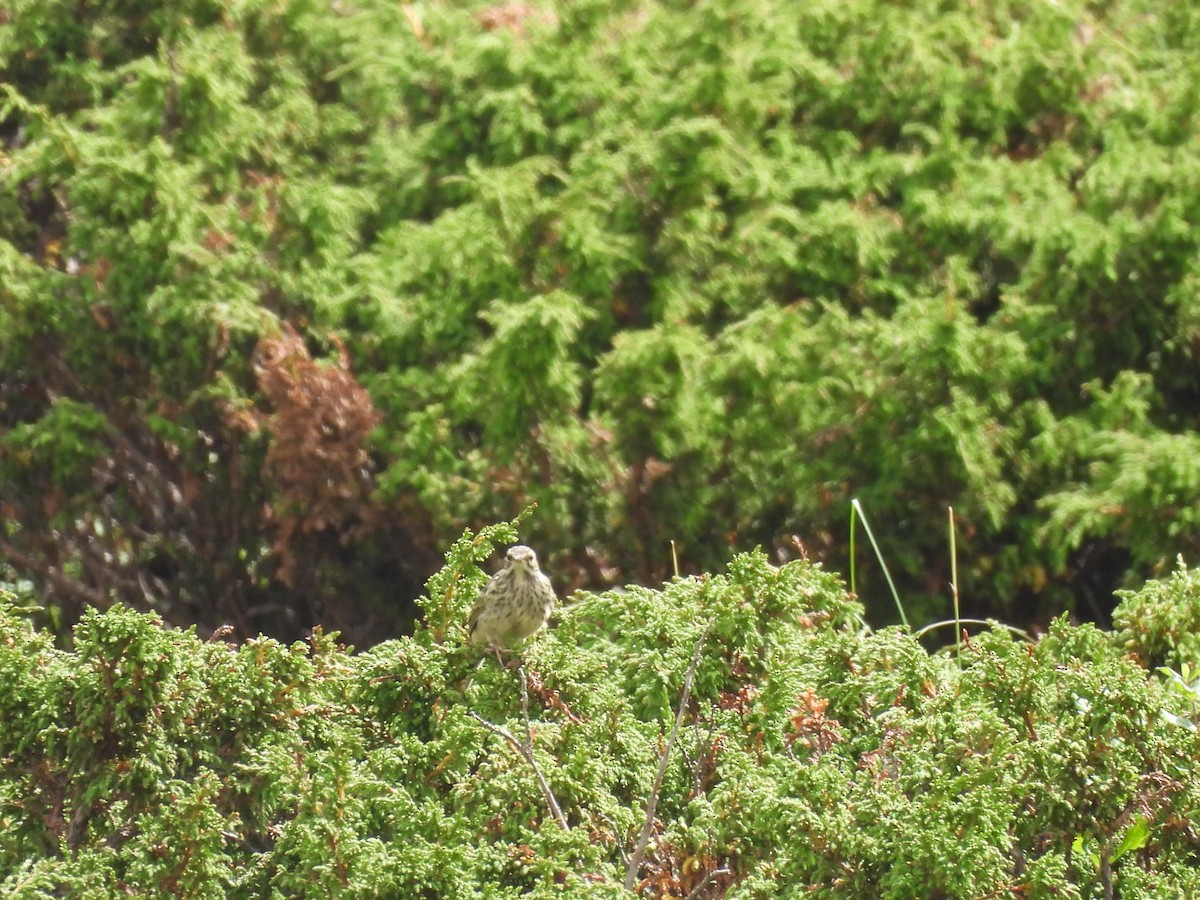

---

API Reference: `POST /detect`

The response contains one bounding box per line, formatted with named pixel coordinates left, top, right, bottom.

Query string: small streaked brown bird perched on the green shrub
left=467, top=544, right=554, bottom=649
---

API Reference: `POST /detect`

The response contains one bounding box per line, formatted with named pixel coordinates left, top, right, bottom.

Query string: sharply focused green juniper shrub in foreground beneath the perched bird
left=0, top=527, right=1200, bottom=900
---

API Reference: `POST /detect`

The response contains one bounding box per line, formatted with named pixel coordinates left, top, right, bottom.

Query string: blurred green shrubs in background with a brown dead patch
left=0, top=0, right=1200, bottom=641
